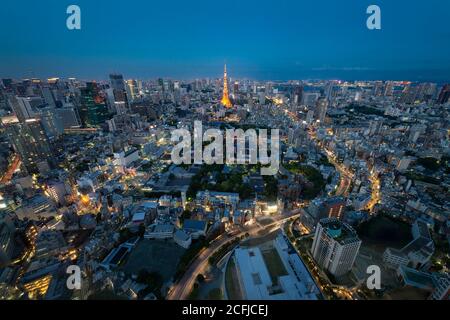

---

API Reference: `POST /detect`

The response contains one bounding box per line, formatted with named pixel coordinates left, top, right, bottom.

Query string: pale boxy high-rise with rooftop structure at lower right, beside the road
left=311, top=218, right=361, bottom=276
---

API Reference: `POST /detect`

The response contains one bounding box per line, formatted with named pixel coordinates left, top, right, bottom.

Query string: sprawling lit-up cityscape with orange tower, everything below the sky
left=0, top=63, right=450, bottom=300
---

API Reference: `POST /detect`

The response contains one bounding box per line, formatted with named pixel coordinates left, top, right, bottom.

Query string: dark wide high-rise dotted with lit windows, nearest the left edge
left=5, top=118, right=53, bottom=173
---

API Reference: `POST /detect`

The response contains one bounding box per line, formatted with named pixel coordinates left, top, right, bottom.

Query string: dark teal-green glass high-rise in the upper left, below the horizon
left=79, top=82, right=109, bottom=126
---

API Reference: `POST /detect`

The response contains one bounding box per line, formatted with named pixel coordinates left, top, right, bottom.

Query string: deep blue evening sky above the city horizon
left=0, top=0, right=450, bottom=81
